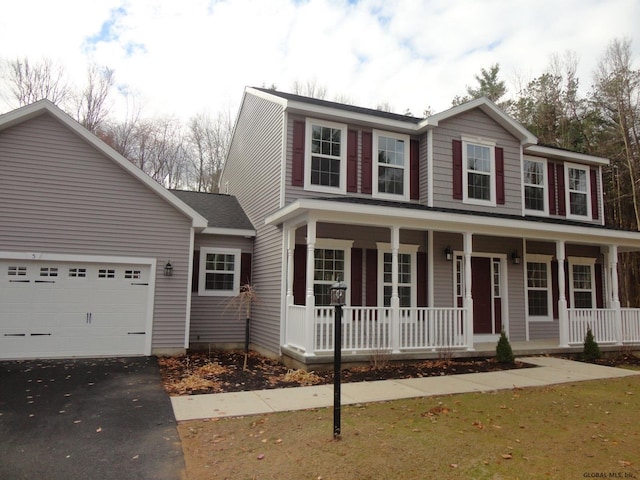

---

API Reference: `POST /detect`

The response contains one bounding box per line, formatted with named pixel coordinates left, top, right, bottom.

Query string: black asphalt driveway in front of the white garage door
left=0, top=357, right=184, bottom=480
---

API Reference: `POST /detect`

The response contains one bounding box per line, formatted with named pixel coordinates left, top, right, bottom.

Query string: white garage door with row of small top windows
left=0, top=260, right=150, bottom=358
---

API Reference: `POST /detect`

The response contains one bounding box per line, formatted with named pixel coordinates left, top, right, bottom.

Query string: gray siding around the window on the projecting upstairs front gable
left=433, top=109, right=522, bottom=215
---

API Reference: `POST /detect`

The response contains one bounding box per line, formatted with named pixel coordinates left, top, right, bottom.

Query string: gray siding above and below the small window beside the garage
left=189, top=235, right=253, bottom=345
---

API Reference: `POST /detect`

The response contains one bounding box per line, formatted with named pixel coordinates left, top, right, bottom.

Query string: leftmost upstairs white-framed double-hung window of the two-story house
left=305, top=119, right=347, bottom=193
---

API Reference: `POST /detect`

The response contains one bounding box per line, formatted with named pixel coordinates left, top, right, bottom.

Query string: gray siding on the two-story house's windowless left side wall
left=221, top=94, right=284, bottom=352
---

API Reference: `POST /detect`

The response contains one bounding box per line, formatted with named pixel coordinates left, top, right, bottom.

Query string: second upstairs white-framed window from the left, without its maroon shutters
left=373, top=130, right=409, bottom=200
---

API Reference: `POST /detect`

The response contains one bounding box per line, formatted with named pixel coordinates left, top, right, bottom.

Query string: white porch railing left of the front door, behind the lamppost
left=286, top=305, right=467, bottom=353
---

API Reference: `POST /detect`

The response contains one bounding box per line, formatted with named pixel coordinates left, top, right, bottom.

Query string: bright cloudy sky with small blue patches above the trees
left=0, top=0, right=640, bottom=118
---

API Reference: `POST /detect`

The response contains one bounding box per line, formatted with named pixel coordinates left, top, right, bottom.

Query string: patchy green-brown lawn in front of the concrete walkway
left=179, top=376, right=640, bottom=480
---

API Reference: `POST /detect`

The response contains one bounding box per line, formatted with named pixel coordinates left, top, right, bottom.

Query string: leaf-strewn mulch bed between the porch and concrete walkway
left=158, top=351, right=531, bottom=395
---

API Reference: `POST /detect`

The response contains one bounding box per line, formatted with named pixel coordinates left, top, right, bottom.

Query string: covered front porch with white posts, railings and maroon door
left=271, top=197, right=640, bottom=363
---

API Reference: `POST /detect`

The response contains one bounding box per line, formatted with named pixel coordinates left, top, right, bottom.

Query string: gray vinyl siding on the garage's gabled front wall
left=0, top=114, right=191, bottom=349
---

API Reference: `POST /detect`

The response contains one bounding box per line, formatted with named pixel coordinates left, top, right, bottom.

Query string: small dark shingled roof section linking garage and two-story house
left=170, top=190, right=256, bottom=237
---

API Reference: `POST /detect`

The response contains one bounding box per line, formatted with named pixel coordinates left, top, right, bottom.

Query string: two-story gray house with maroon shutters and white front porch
left=221, top=88, right=640, bottom=364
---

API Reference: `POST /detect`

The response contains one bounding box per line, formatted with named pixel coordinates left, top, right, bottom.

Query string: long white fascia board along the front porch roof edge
left=265, top=199, right=640, bottom=250
